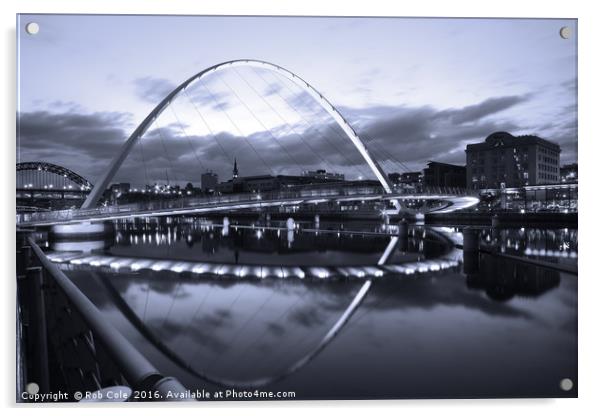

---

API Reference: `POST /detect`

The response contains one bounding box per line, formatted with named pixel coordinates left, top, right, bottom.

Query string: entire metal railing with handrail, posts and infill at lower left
left=17, top=232, right=187, bottom=400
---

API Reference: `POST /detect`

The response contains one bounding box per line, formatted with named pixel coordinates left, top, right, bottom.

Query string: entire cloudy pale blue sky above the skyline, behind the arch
left=17, top=15, right=577, bottom=185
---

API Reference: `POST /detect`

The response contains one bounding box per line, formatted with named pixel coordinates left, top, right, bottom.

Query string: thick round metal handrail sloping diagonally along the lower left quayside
left=27, top=237, right=188, bottom=400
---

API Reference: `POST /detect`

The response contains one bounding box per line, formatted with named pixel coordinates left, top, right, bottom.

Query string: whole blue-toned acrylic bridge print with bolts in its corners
left=16, top=14, right=578, bottom=402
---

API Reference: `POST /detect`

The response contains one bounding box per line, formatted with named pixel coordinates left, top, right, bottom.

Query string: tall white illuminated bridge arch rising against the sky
left=82, top=59, right=399, bottom=209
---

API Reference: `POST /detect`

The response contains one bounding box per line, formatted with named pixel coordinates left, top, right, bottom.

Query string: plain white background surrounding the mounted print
left=0, top=0, right=602, bottom=416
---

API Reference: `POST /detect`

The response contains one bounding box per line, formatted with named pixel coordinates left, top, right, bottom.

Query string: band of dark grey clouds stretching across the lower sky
left=19, top=91, right=577, bottom=185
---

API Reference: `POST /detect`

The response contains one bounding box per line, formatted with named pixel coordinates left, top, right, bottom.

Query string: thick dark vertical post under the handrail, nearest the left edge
left=25, top=267, right=50, bottom=393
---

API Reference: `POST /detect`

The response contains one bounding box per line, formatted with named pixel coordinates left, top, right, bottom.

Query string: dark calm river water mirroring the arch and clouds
left=50, top=219, right=577, bottom=399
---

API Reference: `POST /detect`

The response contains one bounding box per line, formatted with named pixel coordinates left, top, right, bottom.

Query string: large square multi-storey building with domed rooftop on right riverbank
left=466, top=132, right=560, bottom=189
